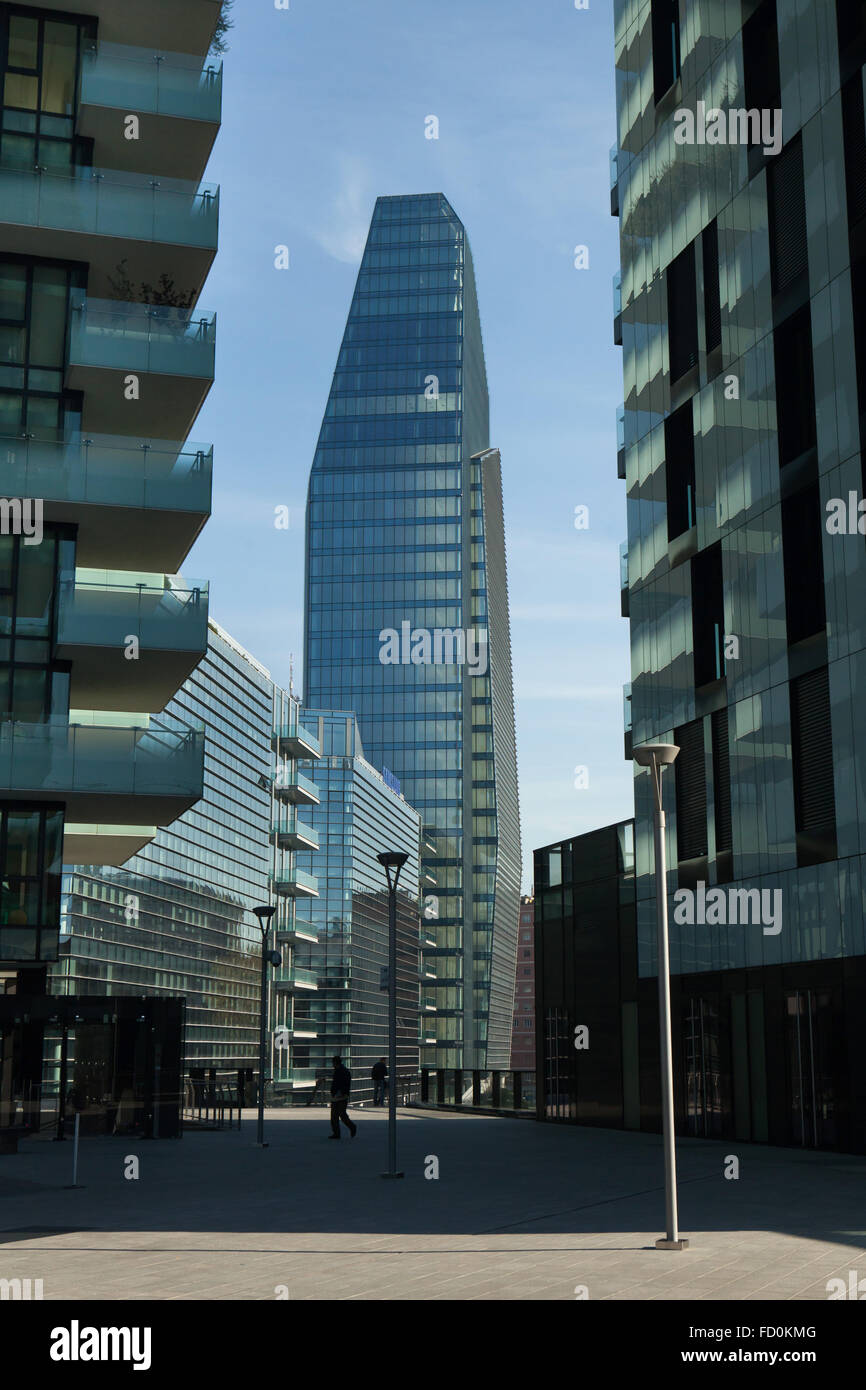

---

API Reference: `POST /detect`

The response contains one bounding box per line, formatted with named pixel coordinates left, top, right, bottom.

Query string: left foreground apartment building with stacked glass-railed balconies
left=0, top=0, right=221, bottom=1123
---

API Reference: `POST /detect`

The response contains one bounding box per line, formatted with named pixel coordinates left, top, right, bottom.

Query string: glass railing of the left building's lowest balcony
left=0, top=714, right=204, bottom=800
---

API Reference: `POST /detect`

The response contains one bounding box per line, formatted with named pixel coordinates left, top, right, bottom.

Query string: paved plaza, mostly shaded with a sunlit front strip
left=0, top=1108, right=866, bottom=1300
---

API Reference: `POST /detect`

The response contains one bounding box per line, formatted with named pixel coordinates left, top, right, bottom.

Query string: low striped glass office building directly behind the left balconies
left=51, top=620, right=291, bottom=1079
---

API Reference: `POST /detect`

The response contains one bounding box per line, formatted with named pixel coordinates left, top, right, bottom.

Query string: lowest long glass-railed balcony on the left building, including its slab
left=0, top=712, right=204, bottom=826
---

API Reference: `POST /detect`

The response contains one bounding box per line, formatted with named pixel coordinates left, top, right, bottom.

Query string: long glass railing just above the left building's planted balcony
left=0, top=168, right=220, bottom=250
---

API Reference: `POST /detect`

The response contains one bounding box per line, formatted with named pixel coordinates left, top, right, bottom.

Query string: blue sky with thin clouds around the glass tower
left=185, top=0, right=632, bottom=890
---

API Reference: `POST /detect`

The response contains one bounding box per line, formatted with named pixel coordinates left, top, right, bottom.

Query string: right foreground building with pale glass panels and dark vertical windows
left=612, top=0, right=866, bottom=1151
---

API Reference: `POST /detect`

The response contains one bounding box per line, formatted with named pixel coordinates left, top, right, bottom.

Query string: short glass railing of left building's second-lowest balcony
left=57, top=570, right=209, bottom=653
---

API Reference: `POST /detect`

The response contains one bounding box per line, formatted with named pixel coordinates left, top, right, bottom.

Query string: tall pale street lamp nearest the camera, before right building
left=632, top=744, right=688, bottom=1250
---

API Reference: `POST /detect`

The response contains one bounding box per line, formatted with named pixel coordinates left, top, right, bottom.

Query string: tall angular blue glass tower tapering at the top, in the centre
left=304, top=193, right=520, bottom=1068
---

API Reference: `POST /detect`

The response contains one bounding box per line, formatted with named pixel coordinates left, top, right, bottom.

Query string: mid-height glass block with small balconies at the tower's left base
left=274, top=706, right=422, bottom=1102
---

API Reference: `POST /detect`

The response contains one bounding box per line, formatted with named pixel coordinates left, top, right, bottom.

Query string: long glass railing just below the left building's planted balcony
left=0, top=431, right=214, bottom=516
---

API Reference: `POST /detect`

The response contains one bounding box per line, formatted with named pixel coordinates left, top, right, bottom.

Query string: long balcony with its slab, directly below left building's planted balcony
left=0, top=431, right=213, bottom=573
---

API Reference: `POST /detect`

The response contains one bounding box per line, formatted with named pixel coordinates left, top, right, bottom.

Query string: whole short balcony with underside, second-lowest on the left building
left=57, top=570, right=209, bottom=712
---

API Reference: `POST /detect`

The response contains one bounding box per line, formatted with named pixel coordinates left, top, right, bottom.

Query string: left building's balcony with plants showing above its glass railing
left=65, top=291, right=217, bottom=439
